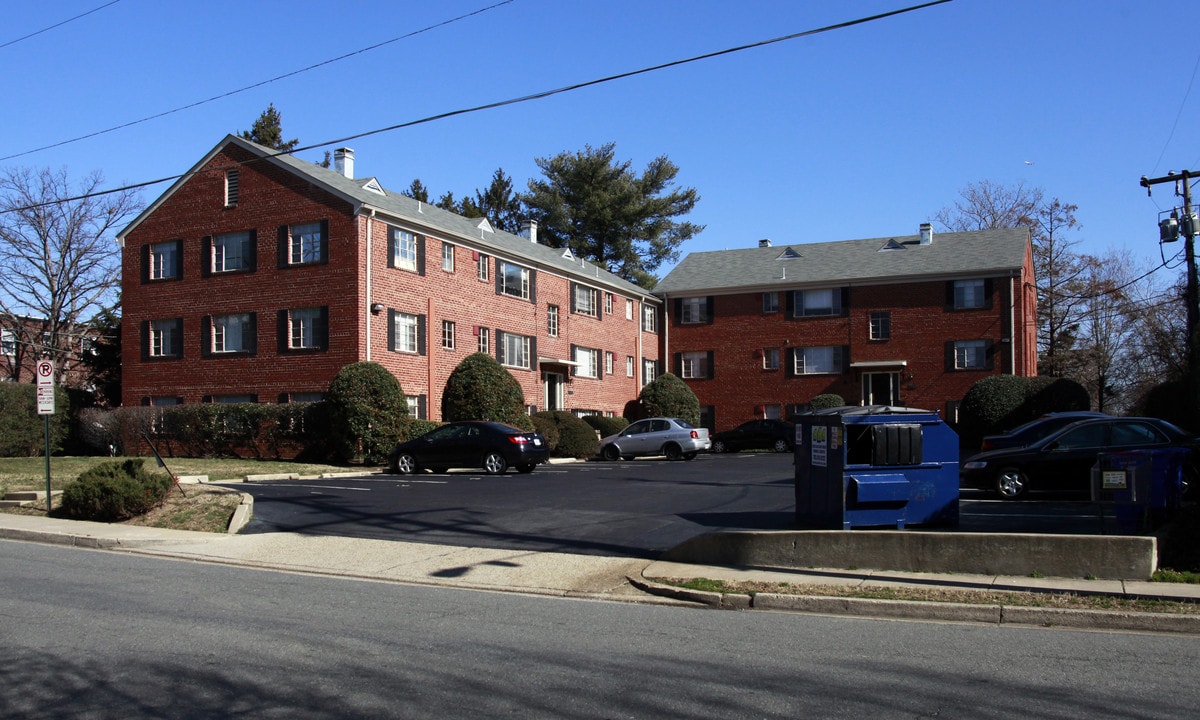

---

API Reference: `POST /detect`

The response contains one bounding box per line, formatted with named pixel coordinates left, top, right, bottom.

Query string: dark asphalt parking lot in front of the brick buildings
left=225, top=454, right=1112, bottom=558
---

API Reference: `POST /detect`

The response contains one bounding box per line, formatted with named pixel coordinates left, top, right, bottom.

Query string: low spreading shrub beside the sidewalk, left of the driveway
left=62, top=458, right=174, bottom=522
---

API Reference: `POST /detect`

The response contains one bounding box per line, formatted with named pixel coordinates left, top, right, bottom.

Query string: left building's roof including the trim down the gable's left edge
left=118, top=134, right=659, bottom=302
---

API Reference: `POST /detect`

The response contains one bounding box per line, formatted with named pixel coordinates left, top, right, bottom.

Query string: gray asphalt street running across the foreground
left=9, top=541, right=1200, bottom=720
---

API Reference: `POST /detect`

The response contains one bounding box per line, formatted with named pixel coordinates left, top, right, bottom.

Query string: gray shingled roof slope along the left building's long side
left=244, top=136, right=655, bottom=299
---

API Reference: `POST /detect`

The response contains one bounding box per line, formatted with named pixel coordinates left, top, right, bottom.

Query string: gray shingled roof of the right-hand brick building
left=654, top=228, right=1030, bottom=296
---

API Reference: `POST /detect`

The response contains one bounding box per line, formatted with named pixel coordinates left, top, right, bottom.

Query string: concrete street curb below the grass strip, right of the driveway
left=629, top=577, right=1200, bottom=635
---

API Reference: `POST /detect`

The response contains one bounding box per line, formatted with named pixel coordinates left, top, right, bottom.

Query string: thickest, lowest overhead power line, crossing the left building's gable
left=0, top=0, right=953, bottom=214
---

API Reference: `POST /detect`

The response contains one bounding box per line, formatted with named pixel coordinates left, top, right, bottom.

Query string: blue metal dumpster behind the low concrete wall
left=794, top=406, right=959, bottom=530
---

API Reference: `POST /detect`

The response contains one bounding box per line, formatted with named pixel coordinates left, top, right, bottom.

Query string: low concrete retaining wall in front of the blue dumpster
left=660, top=530, right=1158, bottom=580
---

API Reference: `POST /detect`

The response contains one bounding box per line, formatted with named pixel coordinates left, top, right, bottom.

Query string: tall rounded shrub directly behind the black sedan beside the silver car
left=442, top=353, right=533, bottom=430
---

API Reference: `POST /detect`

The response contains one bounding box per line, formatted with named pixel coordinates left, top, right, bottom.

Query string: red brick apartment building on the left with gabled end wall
left=118, top=136, right=661, bottom=420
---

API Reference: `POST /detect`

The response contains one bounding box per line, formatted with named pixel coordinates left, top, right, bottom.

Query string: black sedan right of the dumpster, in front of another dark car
left=959, top=416, right=1200, bottom=499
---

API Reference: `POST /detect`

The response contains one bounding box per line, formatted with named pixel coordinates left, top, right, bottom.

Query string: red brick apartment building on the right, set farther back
left=654, top=224, right=1037, bottom=430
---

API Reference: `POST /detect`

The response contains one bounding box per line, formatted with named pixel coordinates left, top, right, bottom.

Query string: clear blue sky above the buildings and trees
left=0, top=0, right=1200, bottom=281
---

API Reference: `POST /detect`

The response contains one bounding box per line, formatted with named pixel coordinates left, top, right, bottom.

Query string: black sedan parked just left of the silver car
left=388, top=420, right=550, bottom=475
